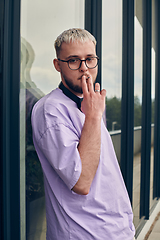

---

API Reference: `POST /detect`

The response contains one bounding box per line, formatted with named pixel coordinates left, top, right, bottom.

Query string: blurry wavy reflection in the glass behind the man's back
left=20, top=38, right=45, bottom=238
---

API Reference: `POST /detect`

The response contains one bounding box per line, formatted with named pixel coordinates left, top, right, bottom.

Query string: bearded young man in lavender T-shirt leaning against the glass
left=32, top=29, right=135, bottom=240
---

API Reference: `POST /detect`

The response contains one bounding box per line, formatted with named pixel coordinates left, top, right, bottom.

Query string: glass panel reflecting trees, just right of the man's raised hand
left=102, top=0, right=122, bottom=161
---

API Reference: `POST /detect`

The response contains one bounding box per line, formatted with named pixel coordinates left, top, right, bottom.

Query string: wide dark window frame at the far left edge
left=1, top=0, right=20, bottom=240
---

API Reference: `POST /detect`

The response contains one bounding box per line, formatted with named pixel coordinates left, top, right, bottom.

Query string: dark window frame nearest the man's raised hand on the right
left=121, top=0, right=134, bottom=203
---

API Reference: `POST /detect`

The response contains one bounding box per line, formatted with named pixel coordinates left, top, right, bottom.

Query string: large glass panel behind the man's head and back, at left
left=20, top=0, right=84, bottom=240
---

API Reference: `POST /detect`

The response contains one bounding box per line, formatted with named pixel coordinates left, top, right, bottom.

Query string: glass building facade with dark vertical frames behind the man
left=0, top=0, right=160, bottom=240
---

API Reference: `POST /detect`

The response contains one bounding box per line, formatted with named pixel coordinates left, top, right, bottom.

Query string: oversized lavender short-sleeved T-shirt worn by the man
left=32, top=88, right=135, bottom=240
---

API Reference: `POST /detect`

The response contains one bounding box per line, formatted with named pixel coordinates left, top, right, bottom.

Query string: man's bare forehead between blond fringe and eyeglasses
left=60, top=40, right=96, bottom=58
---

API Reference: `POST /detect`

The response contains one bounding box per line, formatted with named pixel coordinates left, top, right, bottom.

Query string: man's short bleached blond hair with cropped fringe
left=54, top=28, right=97, bottom=56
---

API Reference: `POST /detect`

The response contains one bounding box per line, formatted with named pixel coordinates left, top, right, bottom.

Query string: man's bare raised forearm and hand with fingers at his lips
left=72, top=76, right=106, bottom=195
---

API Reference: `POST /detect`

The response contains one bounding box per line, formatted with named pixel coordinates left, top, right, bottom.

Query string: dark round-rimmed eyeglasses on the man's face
left=58, top=57, right=99, bottom=70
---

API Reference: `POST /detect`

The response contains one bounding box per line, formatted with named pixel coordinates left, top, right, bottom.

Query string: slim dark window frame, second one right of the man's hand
left=140, top=0, right=152, bottom=219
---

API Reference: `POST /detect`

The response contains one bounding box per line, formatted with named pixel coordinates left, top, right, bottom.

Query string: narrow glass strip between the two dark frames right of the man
left=133, top=1, right=143, bottom=227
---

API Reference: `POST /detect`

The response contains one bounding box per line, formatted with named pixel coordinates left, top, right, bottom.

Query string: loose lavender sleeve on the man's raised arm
left=38, top=123, right=82, bottom=189
